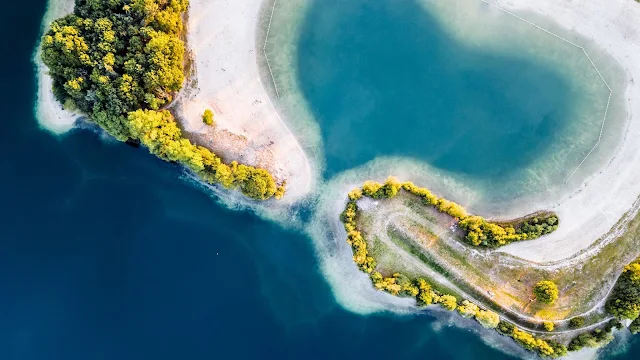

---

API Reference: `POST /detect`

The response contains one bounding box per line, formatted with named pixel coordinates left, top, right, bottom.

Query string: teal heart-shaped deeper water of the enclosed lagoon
left=296, top=0, right=579, bottom=181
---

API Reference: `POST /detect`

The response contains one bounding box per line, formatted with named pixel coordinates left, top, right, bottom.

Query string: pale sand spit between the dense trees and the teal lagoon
left=175, top=0, right=313, bottom=202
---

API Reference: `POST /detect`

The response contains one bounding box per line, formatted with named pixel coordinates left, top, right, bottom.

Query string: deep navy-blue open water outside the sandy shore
left=0, top=0, right=640, bottom=360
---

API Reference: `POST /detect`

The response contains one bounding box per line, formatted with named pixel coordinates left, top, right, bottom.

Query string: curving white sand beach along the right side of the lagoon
left=490, top=0, right=640, bottom=262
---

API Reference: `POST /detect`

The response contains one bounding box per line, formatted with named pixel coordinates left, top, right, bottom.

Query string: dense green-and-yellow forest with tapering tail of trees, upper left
left=42, top=0, right=284, bottom=200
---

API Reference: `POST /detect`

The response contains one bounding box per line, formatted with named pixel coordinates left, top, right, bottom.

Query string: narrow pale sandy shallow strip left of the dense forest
left=33, top=0, right=80, bottom=135
